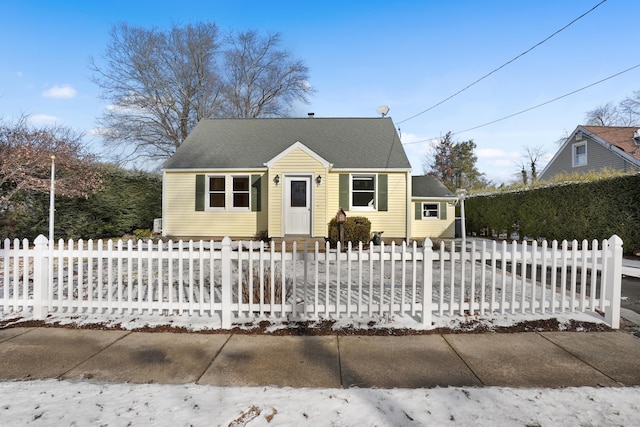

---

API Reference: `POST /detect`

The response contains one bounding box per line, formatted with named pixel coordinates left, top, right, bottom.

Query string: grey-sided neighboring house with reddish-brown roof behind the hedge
left=538, top=126, right=640, bottom=181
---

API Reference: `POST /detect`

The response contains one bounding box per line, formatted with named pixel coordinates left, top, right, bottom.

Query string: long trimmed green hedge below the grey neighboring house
left=465, top=174, right=640, bottom=254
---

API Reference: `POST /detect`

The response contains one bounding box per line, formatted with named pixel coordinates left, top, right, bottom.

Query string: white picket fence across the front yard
left=0, top=236, right=622, bottom=329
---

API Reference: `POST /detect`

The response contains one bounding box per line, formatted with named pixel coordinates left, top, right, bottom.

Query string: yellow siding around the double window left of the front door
left=162, top=171, right=268, bottom=238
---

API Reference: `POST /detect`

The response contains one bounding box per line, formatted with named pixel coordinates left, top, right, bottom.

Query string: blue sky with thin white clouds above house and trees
left=0, top=0, right=640, bottom=184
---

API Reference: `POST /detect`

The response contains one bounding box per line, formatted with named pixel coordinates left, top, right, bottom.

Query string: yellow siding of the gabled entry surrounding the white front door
left=266, top=148, right=327, bottom=237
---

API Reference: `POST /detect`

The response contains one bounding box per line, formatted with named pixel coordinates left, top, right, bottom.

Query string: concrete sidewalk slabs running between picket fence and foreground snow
left=0, top=328, right=640, bottom=388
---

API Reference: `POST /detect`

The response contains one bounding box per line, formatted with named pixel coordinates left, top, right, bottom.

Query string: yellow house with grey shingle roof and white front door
left=162, top=117, right=454, bottom=240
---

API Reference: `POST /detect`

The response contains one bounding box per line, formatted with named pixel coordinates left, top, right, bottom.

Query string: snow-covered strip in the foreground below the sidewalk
left=0, top=380, right=640, bottom=426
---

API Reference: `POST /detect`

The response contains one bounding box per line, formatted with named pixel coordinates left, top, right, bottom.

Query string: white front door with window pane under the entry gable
left=283, top=176, right=311, bottom=236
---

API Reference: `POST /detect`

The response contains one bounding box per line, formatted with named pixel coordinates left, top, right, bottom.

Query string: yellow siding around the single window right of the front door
left=326, top=172, right=407, bottom=239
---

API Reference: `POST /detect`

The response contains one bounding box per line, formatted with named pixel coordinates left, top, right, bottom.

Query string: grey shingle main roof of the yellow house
left=164, top=118, right=411, bottom=170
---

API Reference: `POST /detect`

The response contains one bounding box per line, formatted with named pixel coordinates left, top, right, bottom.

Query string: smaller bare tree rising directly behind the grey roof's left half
left=223, top=31, right=313, bottom=118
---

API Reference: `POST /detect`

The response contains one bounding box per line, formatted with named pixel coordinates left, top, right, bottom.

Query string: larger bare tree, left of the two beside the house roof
left=90, top=23, right=220, bottom=165
